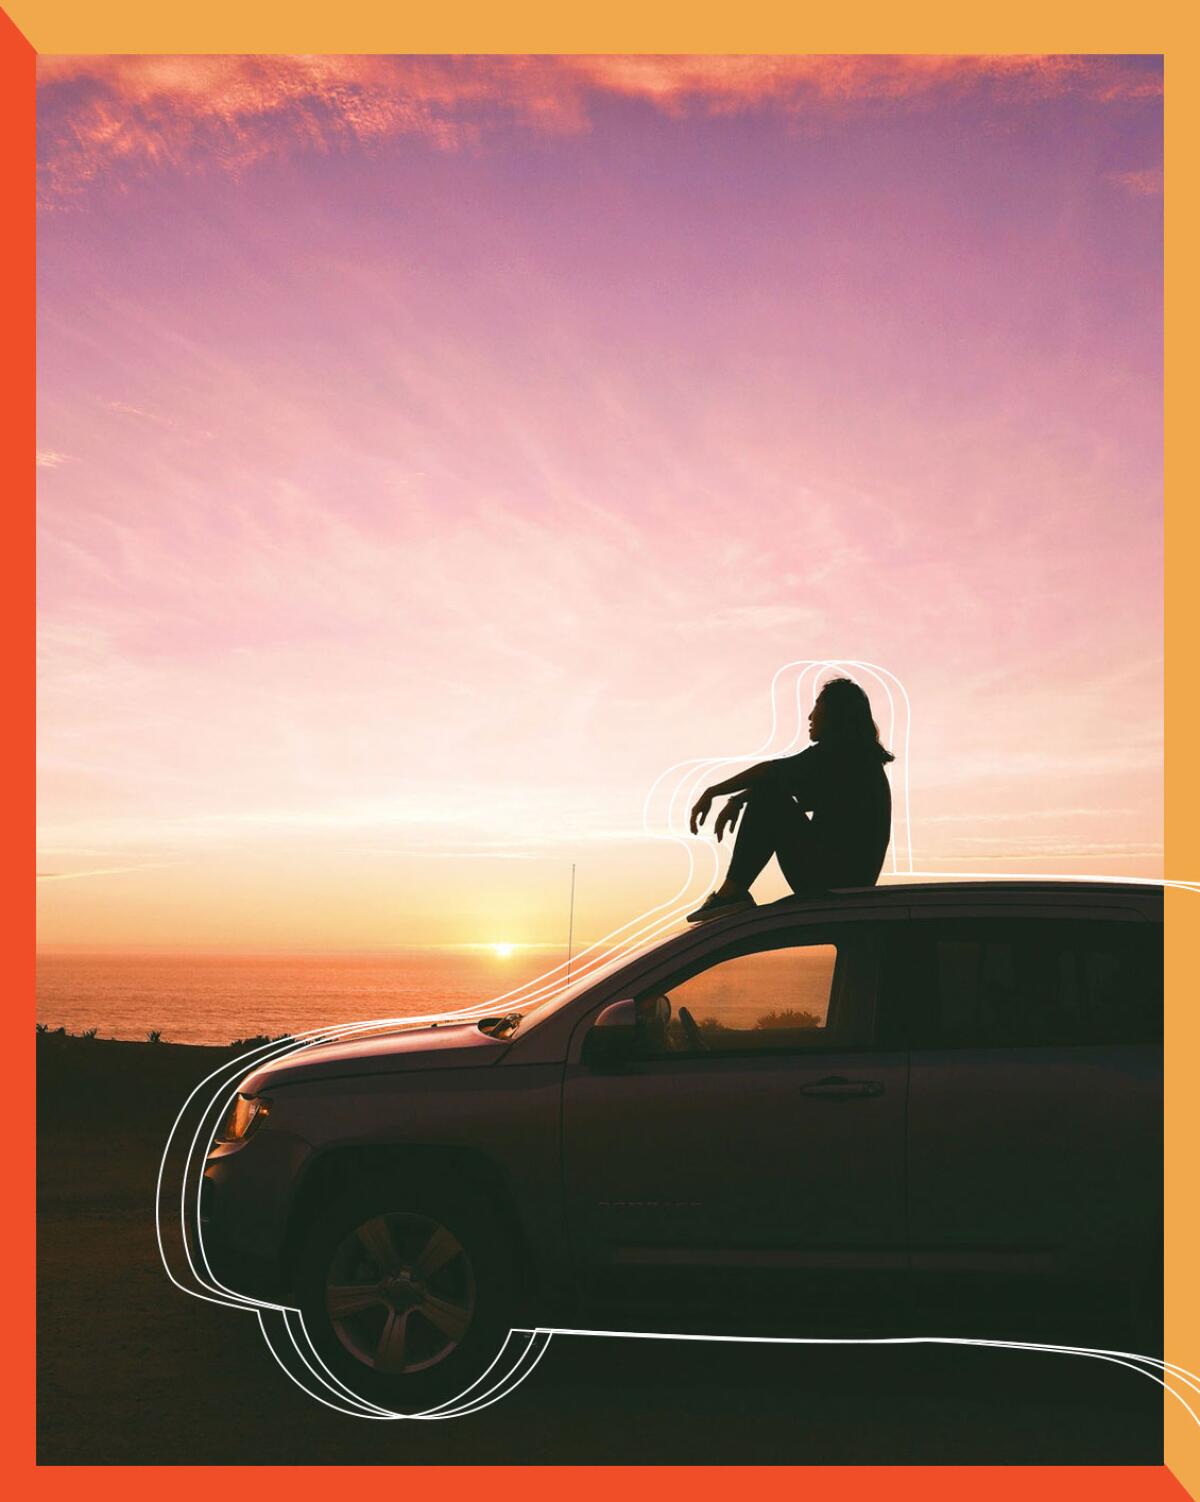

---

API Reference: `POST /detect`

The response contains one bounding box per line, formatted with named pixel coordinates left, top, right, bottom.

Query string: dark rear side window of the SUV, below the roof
left=915, top=919, right=1162, bottom=1048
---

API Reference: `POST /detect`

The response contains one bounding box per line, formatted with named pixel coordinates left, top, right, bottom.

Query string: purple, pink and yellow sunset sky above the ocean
left=38, top=57, right=1162, bottom=951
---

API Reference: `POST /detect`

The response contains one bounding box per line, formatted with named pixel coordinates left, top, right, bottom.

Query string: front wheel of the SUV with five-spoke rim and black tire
left=296, top=1179, right=515, bottom=1413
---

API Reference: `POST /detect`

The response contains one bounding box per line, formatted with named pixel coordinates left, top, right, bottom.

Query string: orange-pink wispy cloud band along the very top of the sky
left=39, top=56, right=1162, bottom=206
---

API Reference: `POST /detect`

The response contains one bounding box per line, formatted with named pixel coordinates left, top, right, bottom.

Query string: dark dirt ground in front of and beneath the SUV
left=38, top=1039, right=1162, bottom=1464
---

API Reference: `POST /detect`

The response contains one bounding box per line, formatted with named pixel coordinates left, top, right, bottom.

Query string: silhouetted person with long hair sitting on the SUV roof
left=688, top=677, right=895, bottom=924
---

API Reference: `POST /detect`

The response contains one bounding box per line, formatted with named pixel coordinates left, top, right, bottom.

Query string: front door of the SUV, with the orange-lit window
left=563, top=922, right=907, bottom=1320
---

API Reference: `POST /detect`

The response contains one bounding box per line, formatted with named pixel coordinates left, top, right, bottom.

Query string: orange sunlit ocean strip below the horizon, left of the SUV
left=38, top=946, right=565, bottom=1044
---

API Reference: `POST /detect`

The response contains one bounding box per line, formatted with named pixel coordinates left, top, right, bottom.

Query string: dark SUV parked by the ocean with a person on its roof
left=200, top=880, right=1162, bottom=1409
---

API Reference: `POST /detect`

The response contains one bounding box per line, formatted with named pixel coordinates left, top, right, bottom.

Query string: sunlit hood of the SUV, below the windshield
left=240, top=1023, right=508, bottom=1095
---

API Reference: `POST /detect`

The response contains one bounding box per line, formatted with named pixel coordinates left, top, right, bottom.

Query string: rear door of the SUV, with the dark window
left=907, top=913, right=1162, bottom=1301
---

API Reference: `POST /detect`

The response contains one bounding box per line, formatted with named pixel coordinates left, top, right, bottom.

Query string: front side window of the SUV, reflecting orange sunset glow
left=638, top=934, right=877, bottom=1056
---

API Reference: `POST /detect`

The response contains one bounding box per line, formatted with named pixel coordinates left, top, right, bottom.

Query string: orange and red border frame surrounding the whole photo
left=11, top=0, right=1200, bottom=1502
